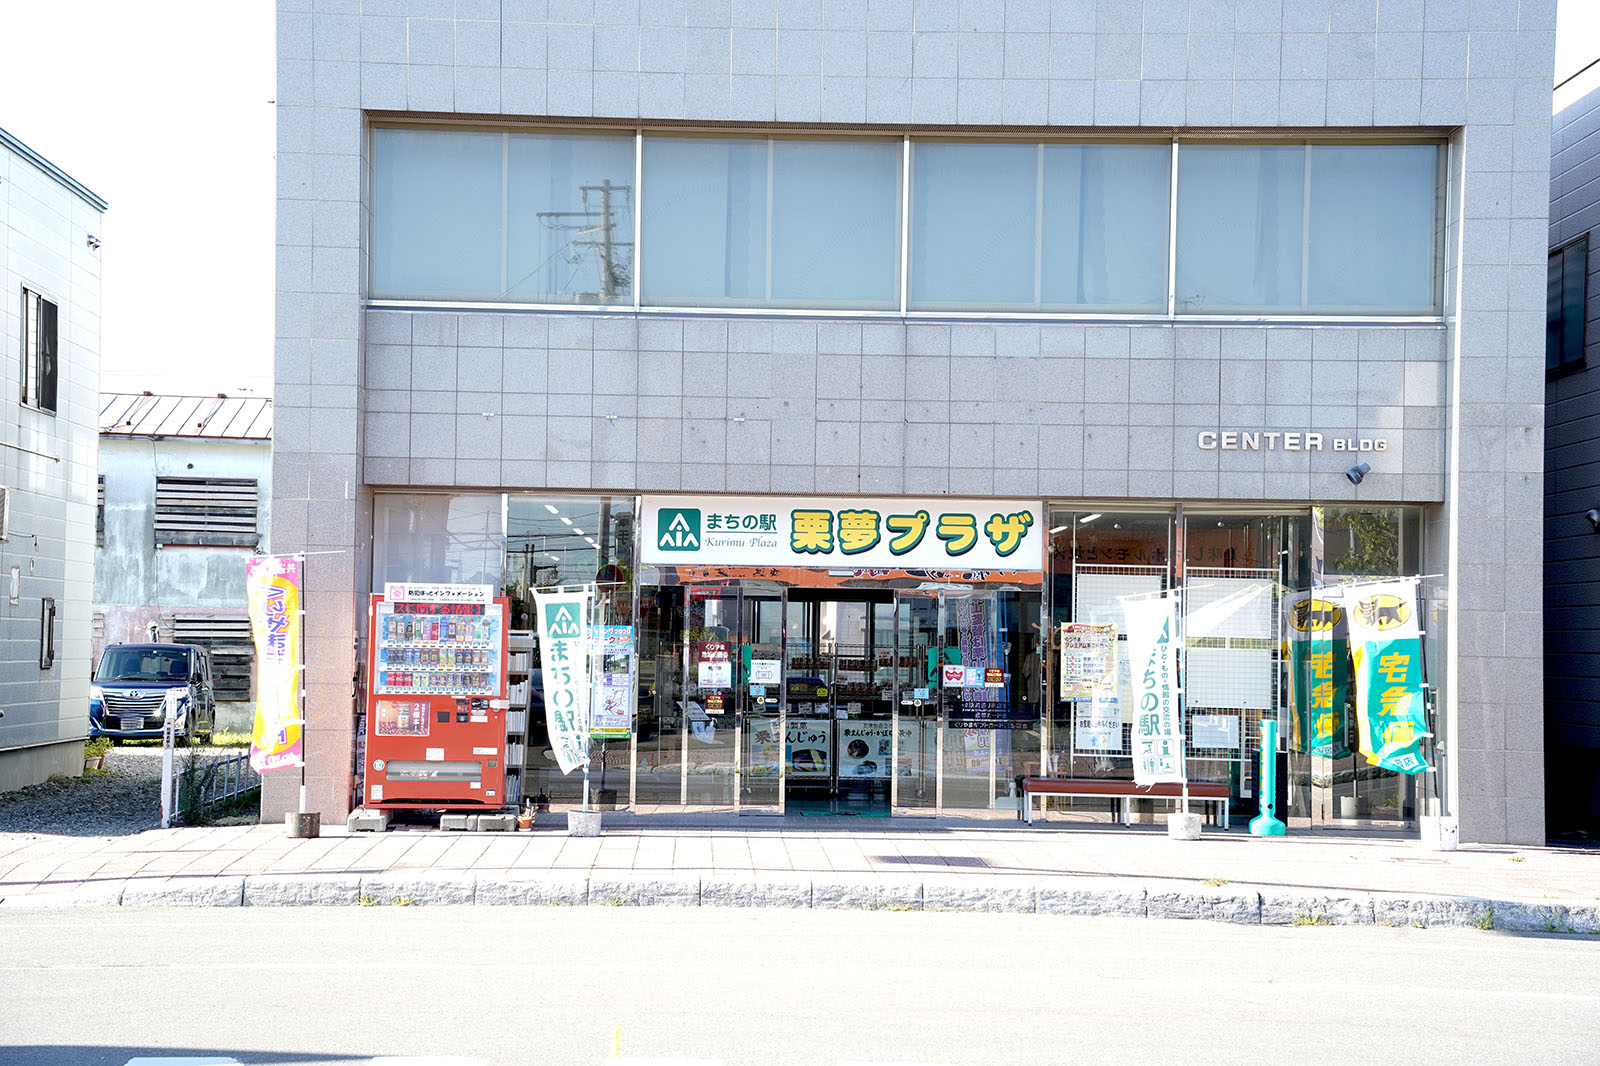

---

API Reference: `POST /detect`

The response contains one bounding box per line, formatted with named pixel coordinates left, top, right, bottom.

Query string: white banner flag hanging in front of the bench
left=1118, top=592, right=1184, bottom=784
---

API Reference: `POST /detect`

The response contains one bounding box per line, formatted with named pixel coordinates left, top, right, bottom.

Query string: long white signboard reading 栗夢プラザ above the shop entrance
left=640, top=496, right=1046, bottom=570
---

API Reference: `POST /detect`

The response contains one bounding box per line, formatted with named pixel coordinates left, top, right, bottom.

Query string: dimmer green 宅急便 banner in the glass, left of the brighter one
left=1283, top=589, right=1350, bottom=759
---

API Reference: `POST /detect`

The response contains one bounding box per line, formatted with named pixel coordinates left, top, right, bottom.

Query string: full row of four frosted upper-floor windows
left=371, top=128, right=1445, bottom=317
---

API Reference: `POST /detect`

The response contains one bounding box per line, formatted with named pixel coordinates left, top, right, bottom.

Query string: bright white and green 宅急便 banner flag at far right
left=1346, top=578, right=1432, bottom=773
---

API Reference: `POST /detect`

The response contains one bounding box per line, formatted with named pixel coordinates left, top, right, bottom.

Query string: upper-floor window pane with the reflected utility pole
left=504, top=133, right=634, bottom=304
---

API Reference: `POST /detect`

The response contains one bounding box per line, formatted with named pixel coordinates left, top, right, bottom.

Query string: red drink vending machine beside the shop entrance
left=362, top=583, right=507, bottom=810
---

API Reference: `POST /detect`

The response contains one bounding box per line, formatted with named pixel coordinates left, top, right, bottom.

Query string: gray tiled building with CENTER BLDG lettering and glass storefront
left=281, top=0, right=1555, bottom=842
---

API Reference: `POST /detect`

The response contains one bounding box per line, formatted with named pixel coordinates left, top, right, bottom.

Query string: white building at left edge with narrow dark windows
left=0, top=130, right=106, bottom=791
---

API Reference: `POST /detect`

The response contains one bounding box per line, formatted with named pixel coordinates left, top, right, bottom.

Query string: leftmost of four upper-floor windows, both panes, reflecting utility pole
left=371, top=130, right=634, bottom=304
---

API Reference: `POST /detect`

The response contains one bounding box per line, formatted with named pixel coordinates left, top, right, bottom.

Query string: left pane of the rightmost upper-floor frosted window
left=1178, top=144, right=1306, bottom=314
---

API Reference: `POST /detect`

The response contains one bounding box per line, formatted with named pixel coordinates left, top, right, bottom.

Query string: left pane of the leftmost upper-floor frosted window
left=373, top=130, right=506, bottom=301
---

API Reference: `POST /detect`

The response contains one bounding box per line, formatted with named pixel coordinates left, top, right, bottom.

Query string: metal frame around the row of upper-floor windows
left=362, top=118, right=1456, bottom=325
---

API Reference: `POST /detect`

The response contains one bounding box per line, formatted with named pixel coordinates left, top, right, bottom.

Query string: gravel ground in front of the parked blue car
left=0, top=744, right=248, bottom=837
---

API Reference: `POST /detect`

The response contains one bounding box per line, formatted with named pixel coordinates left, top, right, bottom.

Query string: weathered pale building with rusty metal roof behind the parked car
left=94, top=392, right=272, bottom=733
